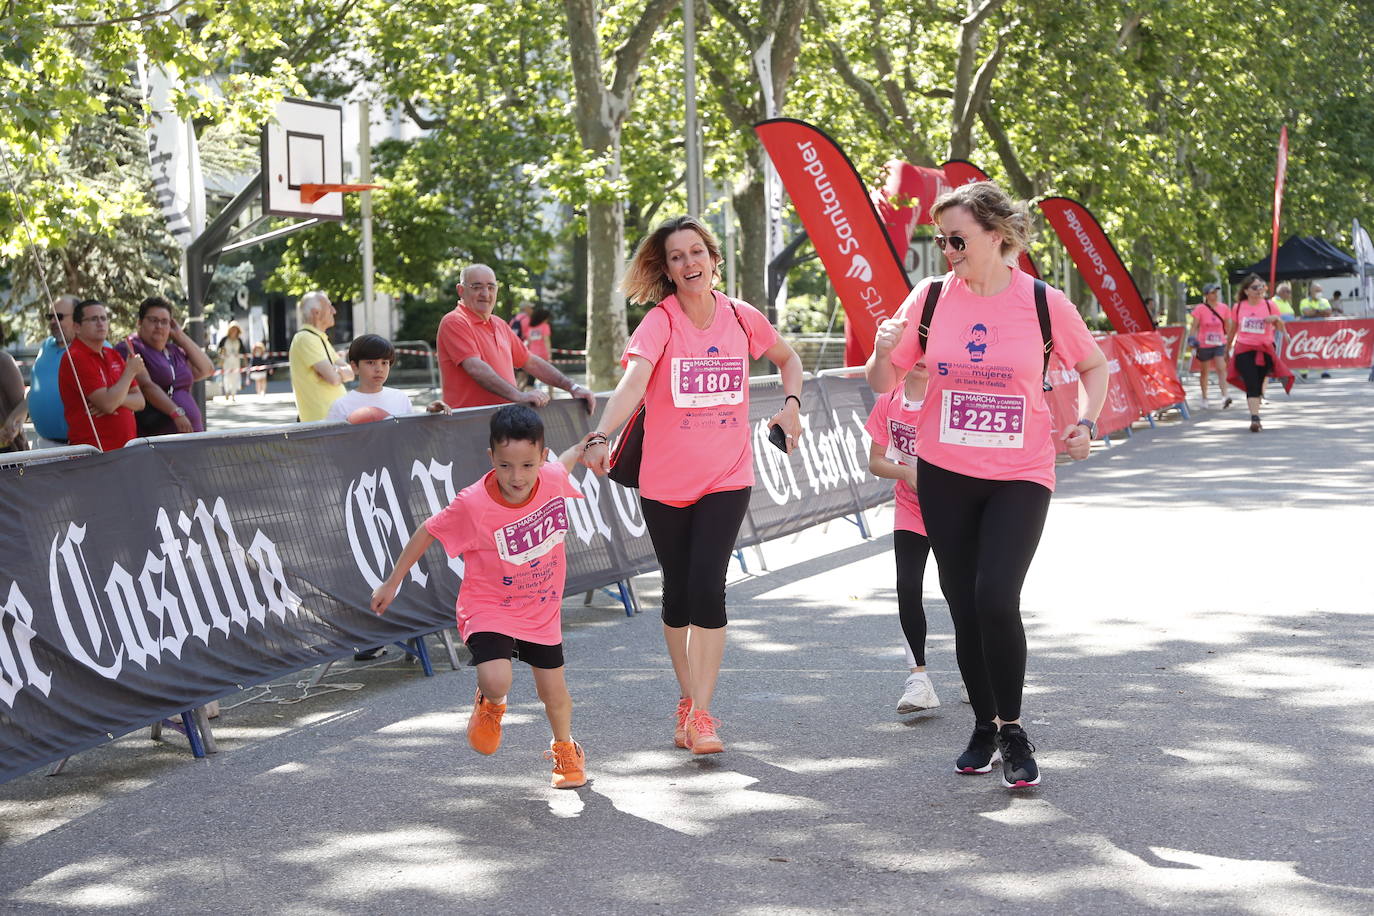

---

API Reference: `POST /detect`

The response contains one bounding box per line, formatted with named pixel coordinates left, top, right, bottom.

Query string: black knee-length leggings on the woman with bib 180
left=639, top=486, right=749, bottom=630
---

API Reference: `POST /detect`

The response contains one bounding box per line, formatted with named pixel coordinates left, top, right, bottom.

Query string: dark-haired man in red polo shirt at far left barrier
left=58, top=299, right=144, bottom=452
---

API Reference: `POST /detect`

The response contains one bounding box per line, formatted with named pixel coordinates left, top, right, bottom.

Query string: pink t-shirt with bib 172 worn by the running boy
left=425, top=459, right=581, bottom=645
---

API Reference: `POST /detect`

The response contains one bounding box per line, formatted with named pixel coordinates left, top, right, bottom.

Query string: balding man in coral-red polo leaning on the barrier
left=438, top=264, right=596, bottom=413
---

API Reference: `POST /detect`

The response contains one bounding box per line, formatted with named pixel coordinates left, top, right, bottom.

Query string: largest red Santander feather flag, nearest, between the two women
left=754, top=118, right=911, bottom=365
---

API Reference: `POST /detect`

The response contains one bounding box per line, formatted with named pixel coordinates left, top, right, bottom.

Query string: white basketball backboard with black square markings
left=262, top=99, right=344, bottom=220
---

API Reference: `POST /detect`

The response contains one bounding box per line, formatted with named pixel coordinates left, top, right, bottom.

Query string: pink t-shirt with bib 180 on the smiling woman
left=621, top=293, right=778, bottom=505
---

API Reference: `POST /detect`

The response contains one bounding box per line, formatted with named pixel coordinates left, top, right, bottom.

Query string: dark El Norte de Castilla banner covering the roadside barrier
left=0, top=378, right=892, bottom=781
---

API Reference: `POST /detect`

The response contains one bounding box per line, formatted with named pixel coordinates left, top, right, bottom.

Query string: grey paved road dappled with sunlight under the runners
left=0, top=372, right=1374, bottom=915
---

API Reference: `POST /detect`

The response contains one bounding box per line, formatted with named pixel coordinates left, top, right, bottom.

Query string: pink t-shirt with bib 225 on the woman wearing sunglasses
left=892, top=269, right=1098, bottom=490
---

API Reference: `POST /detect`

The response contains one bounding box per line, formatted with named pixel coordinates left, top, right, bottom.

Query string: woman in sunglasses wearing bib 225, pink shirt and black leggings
left=867, top=181, right=1107, bottom=788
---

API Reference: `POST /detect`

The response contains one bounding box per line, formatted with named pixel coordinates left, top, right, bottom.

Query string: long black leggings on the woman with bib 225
left=916, top=461, right=1050, bottom=722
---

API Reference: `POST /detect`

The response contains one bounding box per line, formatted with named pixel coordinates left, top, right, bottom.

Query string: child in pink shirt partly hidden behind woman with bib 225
left=864, top=363, right=940, bottom=713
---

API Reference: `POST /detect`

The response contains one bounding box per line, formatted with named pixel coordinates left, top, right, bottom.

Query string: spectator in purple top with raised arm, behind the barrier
left=115, top=295, right=214, bottom=435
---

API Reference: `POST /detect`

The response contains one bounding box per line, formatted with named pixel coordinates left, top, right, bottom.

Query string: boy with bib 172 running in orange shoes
left=372, top=404, right=587, bottom=788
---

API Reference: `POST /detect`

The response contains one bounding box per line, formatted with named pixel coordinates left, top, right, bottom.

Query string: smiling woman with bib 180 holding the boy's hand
left=587, top=217, right=801, bottom=754
